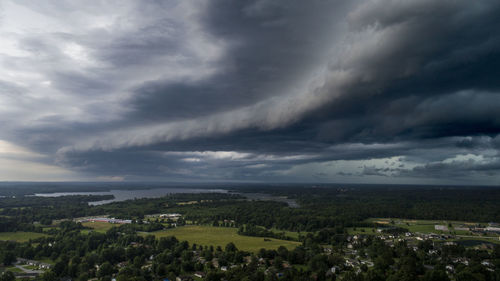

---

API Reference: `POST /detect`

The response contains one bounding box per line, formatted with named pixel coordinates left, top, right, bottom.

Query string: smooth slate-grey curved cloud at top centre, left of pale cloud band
left=129, top=1, right=354, bottom=120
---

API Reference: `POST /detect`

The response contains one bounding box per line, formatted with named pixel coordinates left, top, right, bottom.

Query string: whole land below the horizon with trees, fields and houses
left=0, top=183, right=500, bottom=280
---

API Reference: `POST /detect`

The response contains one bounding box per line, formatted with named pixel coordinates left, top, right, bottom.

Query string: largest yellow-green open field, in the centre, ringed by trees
left=144, top=225, right=300, bottom=252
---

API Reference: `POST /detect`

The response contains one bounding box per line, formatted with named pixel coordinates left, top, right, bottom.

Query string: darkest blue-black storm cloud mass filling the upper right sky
left=300, top=1, right=500, bottom=141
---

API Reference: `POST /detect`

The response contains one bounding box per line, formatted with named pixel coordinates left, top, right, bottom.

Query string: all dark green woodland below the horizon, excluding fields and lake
left=0, top=187, right=500, bottom=281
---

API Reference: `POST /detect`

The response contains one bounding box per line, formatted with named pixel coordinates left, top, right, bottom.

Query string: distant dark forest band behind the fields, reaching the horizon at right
left=0, top=187, right=500, bottom=236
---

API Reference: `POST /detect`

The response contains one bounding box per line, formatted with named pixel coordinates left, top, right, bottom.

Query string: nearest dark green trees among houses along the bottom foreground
left=0, top=222, right=500, bottom=281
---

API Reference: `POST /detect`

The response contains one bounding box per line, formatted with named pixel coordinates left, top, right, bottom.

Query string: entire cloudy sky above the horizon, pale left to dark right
left=0, top=0, right=500, bottom=184
